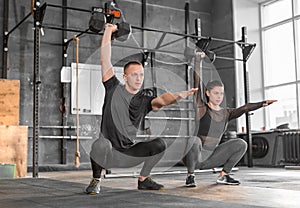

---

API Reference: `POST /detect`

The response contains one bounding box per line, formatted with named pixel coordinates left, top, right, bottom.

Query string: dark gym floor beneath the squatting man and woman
left=0, top=167, right=300, bottom=208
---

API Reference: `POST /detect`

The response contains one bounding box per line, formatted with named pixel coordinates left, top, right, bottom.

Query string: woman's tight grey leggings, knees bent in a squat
left=183, top=137, right=247, bottom=173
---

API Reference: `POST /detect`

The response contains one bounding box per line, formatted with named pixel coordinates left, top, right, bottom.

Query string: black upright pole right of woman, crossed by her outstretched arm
left=242, top=27, right=253, bottom=167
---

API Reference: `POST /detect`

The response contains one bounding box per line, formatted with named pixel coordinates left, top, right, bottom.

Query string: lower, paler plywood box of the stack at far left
left=0, top=126, right=28, bottom=177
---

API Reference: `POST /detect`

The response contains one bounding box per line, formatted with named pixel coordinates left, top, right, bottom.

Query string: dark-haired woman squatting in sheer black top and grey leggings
left=184, top=52, right=277, bottom=187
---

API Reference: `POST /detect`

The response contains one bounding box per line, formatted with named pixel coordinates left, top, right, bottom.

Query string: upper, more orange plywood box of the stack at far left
left=0, top=79, right=20, bottom=126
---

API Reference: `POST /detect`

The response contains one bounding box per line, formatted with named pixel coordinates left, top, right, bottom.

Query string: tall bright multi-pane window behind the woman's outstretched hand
left=261, top=0, right=300, bottom=128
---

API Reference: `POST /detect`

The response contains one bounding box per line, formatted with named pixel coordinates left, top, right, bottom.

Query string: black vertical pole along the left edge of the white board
left=60, top=0, right=69, bottom=164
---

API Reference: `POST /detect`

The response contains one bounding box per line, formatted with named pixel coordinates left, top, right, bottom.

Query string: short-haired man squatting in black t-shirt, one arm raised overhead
left=86, top=24, right=198, bottom=194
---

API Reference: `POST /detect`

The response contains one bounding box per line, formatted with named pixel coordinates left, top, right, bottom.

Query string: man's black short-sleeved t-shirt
left=101, top=76, right=155, bottom=151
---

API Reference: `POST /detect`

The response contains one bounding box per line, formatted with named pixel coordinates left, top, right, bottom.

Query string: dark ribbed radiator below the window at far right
left=283, top=132, right=300, bottom=163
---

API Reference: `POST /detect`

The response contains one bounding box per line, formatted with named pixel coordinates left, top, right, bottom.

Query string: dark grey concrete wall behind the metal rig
left=0, top=0, right=235, bottom=169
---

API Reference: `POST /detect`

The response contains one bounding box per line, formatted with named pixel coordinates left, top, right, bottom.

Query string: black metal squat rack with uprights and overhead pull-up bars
left=2, top=0, right=256, bottom=177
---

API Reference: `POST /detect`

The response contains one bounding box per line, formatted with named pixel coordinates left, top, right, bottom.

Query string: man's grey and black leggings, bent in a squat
left=90, top=137, right=166, bottom=178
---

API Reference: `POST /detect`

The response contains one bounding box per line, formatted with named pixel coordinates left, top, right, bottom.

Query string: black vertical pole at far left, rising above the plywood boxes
left=1, top=0, right=9, bottom=79
